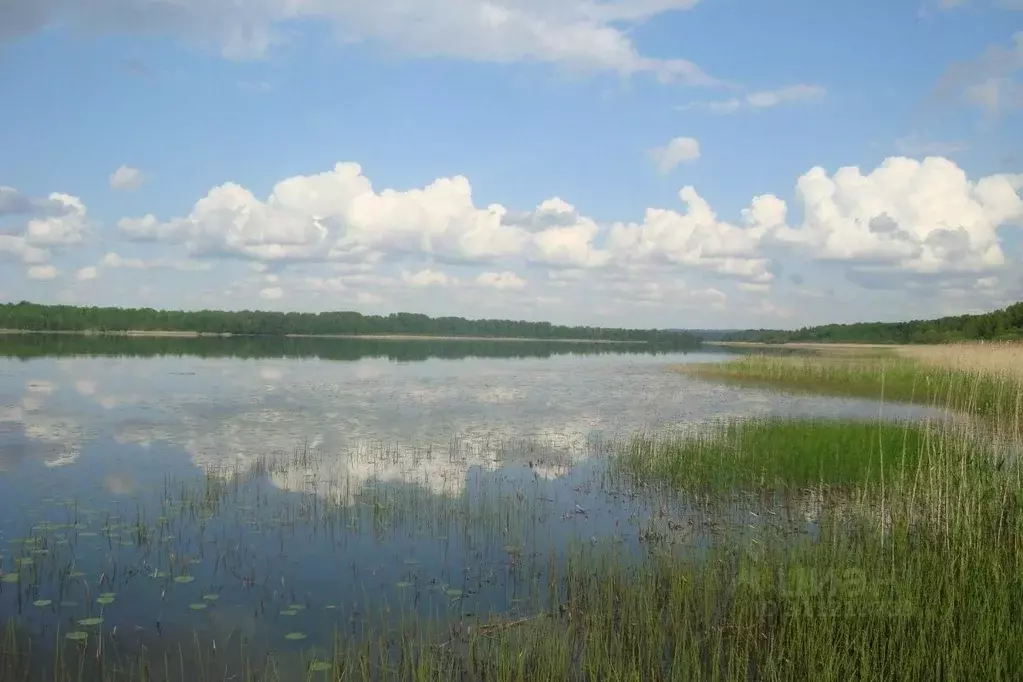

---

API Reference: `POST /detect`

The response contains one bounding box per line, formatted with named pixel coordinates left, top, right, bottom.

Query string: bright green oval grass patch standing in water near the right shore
left=616, top=419, right=937, bottom=493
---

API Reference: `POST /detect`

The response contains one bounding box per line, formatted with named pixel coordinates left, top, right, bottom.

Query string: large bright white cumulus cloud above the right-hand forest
left=772, top=156, right=1023, bottom=273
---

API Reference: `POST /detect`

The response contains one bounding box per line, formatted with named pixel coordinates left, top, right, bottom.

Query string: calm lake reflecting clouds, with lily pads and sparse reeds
left=0, top=335, right=941, bottom=679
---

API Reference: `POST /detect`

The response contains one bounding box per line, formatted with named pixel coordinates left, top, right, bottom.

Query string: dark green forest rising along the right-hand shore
left=723, top=302, right=1023, bottom=344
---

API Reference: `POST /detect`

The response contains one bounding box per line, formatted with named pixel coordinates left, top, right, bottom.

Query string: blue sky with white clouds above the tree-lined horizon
left=0, top=0, right=1023, bottom=328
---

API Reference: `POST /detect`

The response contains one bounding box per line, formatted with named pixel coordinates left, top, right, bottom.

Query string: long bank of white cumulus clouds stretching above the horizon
left=97, top=156, right=1023, bottom=311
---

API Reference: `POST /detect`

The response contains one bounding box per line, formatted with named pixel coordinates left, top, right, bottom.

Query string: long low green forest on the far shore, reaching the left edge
left=0, top=301, right=700, bottom=348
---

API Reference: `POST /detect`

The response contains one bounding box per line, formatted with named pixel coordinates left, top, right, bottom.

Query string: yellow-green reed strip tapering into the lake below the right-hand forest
left=679, top=354, right=1023, bottom=424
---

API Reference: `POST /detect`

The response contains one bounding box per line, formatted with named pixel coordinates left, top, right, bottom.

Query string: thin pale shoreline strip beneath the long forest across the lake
left=0, top=329, right=650, bottom=346
